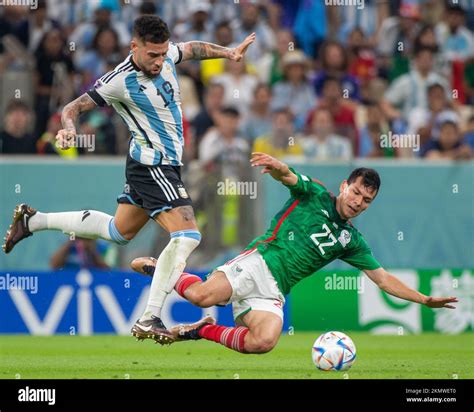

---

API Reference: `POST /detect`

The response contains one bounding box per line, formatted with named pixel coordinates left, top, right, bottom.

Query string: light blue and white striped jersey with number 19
left=88, top=42, right=184, bottom=166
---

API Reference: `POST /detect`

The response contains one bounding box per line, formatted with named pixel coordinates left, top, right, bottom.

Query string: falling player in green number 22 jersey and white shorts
left=132, top=153, right=457, bottom=353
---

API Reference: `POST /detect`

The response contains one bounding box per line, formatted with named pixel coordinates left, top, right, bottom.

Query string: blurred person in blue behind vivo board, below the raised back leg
left=49, top=238, right=110, bottom=270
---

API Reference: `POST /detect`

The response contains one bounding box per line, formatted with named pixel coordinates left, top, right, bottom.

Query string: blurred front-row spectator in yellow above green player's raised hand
left=252, top=108, right=303, bottom=159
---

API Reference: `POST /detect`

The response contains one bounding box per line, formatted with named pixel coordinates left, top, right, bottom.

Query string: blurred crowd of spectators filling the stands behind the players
left=0, top=0, right=474, bottom=161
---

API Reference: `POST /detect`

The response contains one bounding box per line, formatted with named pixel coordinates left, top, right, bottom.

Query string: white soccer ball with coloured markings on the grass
left=312, top=332, right=356, bottom=371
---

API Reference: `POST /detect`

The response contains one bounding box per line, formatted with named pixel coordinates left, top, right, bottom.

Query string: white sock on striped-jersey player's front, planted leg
left=140, top=230, right=201, bottom=320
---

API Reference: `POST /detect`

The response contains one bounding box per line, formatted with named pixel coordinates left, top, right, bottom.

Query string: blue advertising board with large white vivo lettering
left=0, top=269, right=288, bottom=335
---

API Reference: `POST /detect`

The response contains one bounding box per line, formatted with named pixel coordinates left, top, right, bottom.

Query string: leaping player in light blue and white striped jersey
left=3, top=15, right=255, bottom=344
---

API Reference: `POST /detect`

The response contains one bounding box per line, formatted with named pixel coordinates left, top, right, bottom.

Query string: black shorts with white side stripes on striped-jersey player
left=117, top=156, right=192, bottom=218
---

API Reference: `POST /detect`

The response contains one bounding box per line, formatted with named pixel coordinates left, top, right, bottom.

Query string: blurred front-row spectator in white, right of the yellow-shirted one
left=301, top=109, right=352, bottom=162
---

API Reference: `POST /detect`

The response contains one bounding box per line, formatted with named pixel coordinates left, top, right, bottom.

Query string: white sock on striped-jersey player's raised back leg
left=28, top=210, right=128, bottom=244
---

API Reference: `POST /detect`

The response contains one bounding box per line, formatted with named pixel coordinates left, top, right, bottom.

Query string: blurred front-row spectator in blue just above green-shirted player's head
left=359, top=101, right=399, bottom=157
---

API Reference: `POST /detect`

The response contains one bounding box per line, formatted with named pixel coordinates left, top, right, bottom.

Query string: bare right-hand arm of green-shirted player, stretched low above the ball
left=364, top=268, right=458, bottom=309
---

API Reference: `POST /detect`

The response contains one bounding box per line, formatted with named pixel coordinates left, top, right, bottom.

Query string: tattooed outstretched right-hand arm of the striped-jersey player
left=179, top=33, right=255, bottom=62
